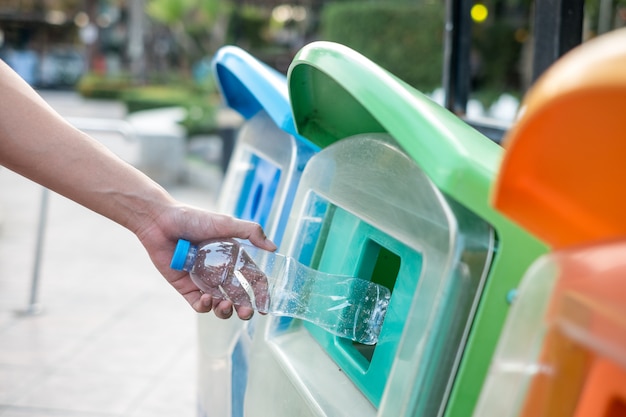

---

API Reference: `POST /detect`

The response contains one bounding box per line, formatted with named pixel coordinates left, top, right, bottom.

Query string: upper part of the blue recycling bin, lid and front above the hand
left=213, top=46, right=319, bottom=245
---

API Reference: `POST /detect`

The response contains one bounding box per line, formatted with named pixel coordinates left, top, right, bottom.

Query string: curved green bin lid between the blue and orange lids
left=288, top=42, right=503, bottom=218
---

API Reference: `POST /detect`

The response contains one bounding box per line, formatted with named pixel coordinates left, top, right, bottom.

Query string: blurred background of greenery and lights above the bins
left=0, top=0, right=626, bottom=132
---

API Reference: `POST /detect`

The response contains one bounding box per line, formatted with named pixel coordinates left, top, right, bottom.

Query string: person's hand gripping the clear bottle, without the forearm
left=135, top=205, right=276, bottom=320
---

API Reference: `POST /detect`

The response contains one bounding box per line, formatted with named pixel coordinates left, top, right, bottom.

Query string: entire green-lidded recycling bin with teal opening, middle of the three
left=236, top=42, right=546, bottom=417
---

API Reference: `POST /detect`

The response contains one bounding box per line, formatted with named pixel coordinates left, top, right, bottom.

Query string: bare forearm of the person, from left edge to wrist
left=0, top=61, right=174, bottom=232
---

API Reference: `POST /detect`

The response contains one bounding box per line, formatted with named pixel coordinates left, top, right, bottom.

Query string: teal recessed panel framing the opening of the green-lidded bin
left=305, top=207, right=422, bottom=406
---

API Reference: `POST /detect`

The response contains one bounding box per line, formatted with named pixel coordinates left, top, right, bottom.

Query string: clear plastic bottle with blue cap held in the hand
left=171, top=239, right=391, bottom=344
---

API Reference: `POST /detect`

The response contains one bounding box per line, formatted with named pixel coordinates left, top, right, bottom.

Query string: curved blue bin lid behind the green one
left=213, top=46, right=298, bottom=136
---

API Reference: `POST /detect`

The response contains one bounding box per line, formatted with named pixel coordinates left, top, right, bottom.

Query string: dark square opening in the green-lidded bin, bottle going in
left=352, top=240, right=401, bottom=363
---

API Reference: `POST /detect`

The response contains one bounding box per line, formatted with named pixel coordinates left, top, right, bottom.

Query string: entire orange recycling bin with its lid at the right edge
left=473, top=30, right=626, bottom=417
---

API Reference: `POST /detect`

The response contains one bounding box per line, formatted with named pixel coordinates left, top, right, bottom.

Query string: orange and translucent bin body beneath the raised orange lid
left=473, top=240, right=626, bottom=417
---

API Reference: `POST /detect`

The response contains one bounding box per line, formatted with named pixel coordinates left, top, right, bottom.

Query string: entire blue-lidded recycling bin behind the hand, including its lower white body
left=198, top=46, right=318, bottom=417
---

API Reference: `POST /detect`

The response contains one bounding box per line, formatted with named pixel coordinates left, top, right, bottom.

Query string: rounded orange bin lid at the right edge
left=494, top=29, right=626, bottom=248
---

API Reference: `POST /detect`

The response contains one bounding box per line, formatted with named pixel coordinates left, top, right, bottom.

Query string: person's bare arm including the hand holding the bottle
left=0, top=61, right=276, bottom=318
